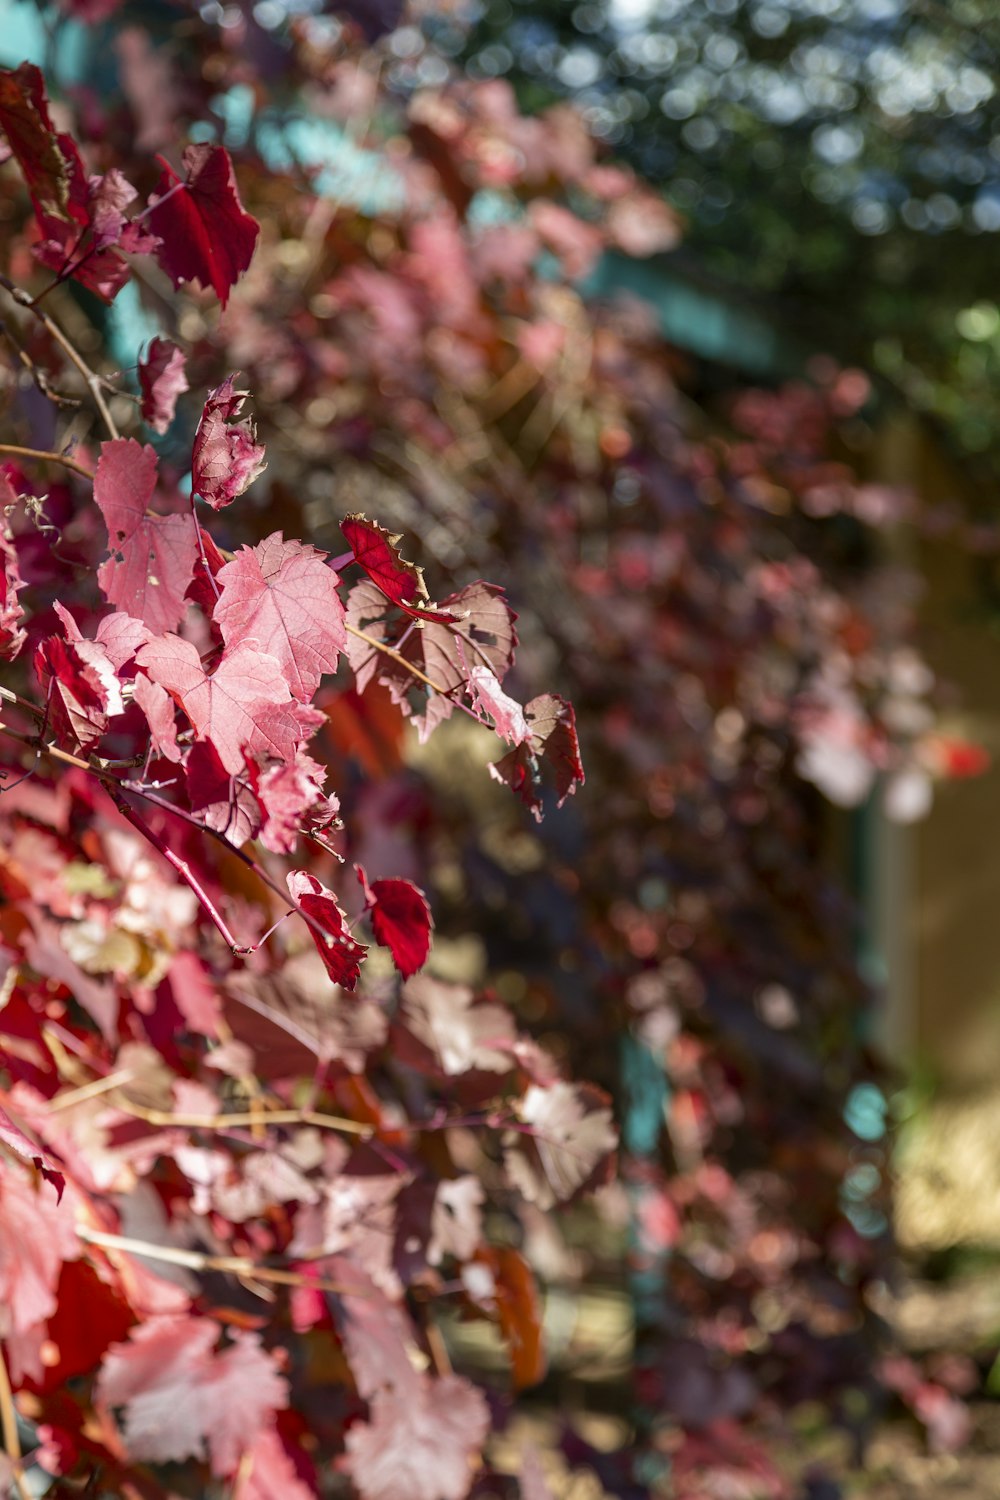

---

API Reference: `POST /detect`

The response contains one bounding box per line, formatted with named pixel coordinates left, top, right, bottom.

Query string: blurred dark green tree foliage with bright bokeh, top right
left=458, top=0, right=1000, bottom=479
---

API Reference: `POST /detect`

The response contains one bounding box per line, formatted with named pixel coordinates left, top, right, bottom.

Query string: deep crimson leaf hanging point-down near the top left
left=150, top=146, right=259, bottom=308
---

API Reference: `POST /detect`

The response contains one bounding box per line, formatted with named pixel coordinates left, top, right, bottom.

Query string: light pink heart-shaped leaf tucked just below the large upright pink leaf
left=135, top=635, right=296, bottom=774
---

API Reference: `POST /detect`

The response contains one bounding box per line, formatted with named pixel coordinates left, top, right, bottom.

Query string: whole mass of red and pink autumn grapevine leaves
left=0, top=8, right=983, bottom=1500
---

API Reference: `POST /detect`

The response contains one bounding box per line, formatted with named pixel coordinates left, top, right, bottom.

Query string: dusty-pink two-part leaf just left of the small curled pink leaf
left=94, top=438, right=198, bottom=635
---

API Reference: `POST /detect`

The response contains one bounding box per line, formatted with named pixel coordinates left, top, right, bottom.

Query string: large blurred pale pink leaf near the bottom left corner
left=97, top=1317, right=288, bottom=1475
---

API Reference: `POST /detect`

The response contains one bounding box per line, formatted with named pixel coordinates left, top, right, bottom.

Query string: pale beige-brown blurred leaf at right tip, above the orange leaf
left=504, top=1083, right=618, bottom=1209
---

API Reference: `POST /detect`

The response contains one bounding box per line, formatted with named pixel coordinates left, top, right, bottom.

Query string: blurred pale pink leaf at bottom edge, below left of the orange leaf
left=346, top=1376, right=489, bottom=1500
